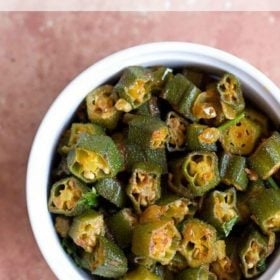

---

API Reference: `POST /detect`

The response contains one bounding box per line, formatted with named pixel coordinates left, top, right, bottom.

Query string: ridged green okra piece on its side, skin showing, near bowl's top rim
left=161, top=74, right=201, bottom=121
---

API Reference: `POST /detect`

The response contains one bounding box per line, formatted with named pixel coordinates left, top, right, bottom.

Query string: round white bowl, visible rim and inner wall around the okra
left=26, top=42, right=280, bottom=280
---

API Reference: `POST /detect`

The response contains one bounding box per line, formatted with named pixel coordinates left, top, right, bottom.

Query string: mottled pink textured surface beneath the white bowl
left=0, top=12, right=280, bottom=280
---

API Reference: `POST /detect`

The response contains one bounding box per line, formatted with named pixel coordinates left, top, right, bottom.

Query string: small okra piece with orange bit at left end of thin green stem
left=186, top=123, right=219, bottom=152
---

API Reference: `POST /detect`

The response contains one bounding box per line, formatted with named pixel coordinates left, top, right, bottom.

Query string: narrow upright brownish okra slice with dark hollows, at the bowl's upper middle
left=166, top=111, right=188, bottom=152
